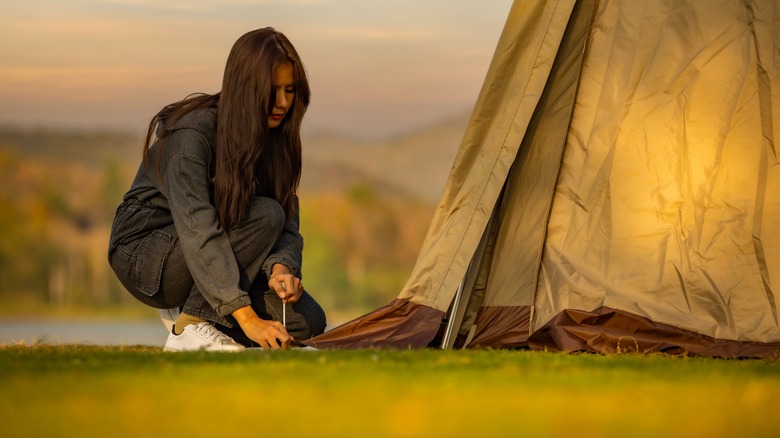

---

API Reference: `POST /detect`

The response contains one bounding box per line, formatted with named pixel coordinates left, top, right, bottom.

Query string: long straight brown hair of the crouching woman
left=144, top=27, right=311, bottom=228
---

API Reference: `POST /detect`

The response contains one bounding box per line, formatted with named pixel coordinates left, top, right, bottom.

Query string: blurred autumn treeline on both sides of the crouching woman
left=0, top=129, right=434, bottom=320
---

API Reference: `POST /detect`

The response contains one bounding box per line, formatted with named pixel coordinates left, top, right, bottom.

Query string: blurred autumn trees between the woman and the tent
left=301, top=184, right=433, bottom=318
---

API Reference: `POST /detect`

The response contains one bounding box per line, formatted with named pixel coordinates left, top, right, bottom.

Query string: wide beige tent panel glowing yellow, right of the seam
left=531, top=0, right=780, bottom=342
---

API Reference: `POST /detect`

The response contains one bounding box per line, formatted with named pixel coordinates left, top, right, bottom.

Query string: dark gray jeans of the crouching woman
left=109, top=198, right=326, bottom=344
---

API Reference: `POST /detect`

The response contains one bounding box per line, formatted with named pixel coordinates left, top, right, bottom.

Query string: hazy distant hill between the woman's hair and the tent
left=302, top=111, right=468, bottom=203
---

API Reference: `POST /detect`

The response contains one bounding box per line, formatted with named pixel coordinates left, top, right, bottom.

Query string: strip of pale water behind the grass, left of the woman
left=0, top=319, right=167, bottom=347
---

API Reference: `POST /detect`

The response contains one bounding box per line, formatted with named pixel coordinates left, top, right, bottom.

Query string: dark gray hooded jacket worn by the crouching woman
left=109, top=109, right=303, bottom=317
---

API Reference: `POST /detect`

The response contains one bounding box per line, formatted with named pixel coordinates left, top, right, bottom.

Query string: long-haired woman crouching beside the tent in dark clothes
left=109, top=28, right=325, bottom=351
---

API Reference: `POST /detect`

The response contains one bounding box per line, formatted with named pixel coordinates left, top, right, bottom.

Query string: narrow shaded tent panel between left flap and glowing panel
left=460, top=1, right=595, bottom=346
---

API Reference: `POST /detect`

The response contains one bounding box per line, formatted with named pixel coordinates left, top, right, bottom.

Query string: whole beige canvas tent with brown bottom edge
left=309, top=0, right=780, bottom=357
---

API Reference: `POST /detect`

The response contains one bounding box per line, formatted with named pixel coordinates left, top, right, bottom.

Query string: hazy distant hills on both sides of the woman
left=0, top=111, right=468, bottom=204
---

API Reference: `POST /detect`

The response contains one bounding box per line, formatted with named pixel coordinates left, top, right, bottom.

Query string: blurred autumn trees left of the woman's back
left=0, top=149, right=129, bottom=314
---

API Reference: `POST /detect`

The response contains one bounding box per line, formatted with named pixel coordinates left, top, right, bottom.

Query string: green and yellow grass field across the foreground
left=0, top=345, right=780, bottom=438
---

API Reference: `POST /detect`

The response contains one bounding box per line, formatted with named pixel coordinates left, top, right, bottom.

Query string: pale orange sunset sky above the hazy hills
left=0, top=0, right=511, bottom=138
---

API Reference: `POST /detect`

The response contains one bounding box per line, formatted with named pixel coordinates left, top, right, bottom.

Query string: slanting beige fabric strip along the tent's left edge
left=399, top=0, right=574, bottom=311
